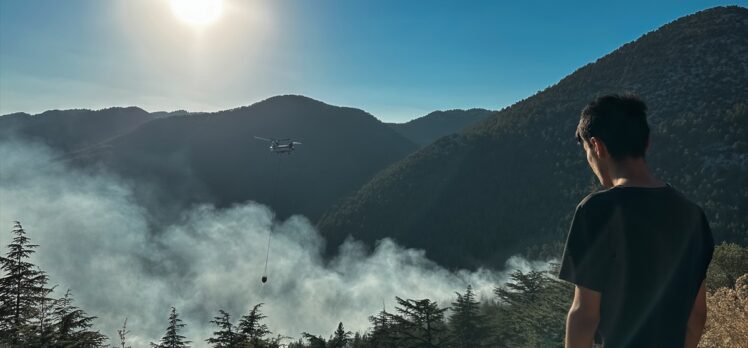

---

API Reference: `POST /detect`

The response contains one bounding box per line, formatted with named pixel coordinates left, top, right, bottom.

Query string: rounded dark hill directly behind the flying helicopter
left=54, top=95, right=416, bottom=219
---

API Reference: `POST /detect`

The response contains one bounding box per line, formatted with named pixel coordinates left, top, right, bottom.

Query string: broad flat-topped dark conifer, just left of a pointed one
left=389, top=297, right=449, bottom=348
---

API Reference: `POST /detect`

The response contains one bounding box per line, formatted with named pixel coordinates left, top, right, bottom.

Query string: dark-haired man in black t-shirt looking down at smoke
left=559, top=95, right=714, bottom=348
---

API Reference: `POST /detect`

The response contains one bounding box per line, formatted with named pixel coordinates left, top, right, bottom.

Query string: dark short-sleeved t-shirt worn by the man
left=559, top=185, right=714, bottom=348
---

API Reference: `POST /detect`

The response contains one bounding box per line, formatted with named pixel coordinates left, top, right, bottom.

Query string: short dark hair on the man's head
left=576, top=94, right=649, bottom=161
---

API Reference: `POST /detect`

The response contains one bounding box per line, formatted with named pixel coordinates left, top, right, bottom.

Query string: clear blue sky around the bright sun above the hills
left=0, top=0, right=746, bottom=122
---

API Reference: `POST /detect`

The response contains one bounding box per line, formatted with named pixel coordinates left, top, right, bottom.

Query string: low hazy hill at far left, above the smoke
left=0, top=107, right=153, bottom=152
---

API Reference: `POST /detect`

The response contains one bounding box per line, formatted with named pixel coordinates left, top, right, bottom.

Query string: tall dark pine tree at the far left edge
left=0, top=221, right=50, bottom=347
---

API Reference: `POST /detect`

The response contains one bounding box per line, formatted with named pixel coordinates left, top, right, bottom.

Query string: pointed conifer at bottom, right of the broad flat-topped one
left=449, top=285, right=488, bottom=348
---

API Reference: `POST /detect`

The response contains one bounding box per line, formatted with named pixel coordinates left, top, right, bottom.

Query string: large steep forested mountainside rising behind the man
left=318, top=7, right=748, bottom=267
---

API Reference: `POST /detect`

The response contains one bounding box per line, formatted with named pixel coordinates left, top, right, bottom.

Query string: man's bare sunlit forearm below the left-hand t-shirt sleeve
left=566, top=285, right=600, bottom=348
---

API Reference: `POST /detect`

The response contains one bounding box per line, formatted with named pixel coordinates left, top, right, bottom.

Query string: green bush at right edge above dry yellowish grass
left=706, top=243, right=748, bottom=291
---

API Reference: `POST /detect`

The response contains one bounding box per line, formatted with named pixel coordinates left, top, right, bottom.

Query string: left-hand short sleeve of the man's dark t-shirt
left=558, top=205, right=609, bottom=292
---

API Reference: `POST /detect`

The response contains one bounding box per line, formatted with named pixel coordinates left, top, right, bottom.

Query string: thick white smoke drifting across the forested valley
left=0, top=141, right=546, bottom=347
